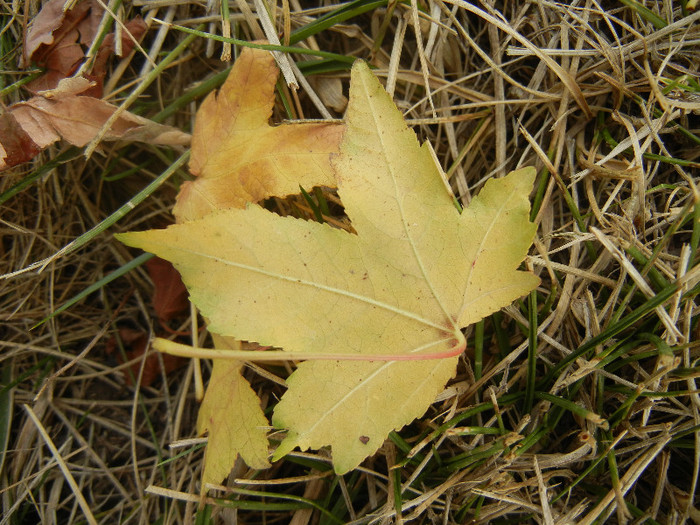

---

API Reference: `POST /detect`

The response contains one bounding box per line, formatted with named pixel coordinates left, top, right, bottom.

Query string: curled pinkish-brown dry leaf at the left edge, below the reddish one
left=0, top=77, right=190, bottom=170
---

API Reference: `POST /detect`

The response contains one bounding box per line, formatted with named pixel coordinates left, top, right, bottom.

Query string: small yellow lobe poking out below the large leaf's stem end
left=197, top=335, right=270, bottom=484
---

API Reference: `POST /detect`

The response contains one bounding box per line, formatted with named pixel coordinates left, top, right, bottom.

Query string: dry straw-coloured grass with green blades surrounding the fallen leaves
left=0, top=0, right=700, bottom=525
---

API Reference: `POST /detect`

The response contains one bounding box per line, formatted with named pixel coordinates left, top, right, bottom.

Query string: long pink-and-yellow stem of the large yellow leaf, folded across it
left=153, top=330, right=467, bottom=361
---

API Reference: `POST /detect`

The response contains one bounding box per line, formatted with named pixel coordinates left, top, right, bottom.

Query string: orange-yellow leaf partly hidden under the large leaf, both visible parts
left=168, top=48, right=344, bottom=484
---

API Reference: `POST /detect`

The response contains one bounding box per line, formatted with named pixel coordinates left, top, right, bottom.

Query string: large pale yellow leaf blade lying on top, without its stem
left=119, top=62, right=538, bottom=473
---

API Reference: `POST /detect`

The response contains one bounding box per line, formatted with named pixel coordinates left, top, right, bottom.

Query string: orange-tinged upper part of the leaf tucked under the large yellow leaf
left=173, top=48, right=344, bottom=222
